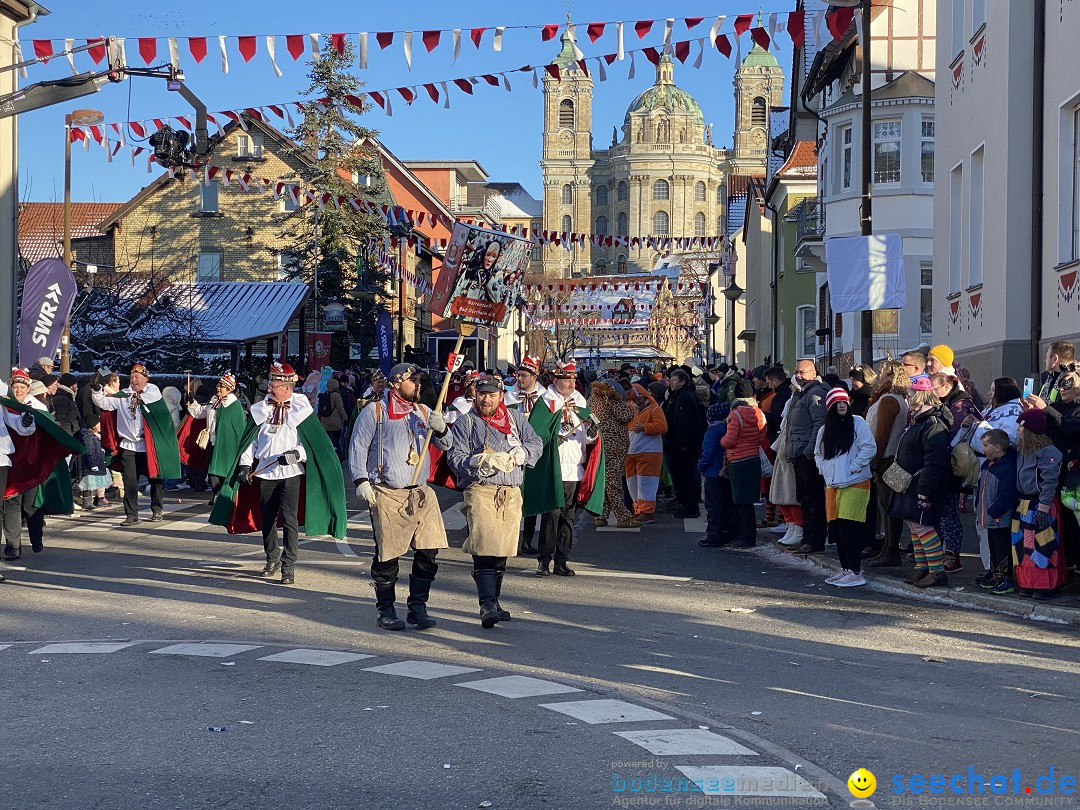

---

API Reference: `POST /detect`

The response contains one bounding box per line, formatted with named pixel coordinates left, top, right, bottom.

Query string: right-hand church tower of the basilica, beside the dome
left=731, top=43, right=784, bottom=175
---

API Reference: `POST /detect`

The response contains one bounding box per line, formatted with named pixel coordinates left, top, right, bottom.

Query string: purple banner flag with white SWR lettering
left=18, top=258, right=79, bottom=368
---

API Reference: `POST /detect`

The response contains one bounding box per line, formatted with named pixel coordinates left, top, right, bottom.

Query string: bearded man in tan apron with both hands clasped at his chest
left=447, top=377, right=543, bottom=627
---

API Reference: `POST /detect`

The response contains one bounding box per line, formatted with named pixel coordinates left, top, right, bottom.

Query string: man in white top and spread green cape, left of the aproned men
left=210, top=362, right=347, bottom=585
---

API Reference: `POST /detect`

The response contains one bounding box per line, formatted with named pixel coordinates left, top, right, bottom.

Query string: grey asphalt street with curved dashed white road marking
left=0, top=492, right=1080, bottom=808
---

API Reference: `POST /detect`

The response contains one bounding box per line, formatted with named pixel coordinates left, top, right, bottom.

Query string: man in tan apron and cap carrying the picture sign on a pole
left=349, top=363, right=451, bottom=631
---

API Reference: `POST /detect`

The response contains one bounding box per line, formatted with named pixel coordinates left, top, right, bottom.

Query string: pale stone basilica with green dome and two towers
left=540, top=32, right=784, bottom=278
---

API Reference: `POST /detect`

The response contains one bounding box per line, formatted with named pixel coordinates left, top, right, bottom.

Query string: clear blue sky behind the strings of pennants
left=19, top=0, right=794, bottom=202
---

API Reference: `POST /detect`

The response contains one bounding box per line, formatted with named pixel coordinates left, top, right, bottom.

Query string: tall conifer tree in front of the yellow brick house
left=282, top=36, right=390, bottom=367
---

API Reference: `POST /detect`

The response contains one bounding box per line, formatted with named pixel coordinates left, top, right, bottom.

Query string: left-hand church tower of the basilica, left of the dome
left=540, top=19, right=593, bottom=278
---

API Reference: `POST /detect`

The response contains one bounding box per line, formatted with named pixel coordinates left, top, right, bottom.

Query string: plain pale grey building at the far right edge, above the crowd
left=933, top=0, right=1080, bottom=389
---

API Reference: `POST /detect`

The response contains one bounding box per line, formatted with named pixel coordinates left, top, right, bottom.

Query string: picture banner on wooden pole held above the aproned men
left=431, top=222, right=532, bottom=326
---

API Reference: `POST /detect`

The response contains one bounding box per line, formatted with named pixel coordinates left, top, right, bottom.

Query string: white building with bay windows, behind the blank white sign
left=797, top=0, right=935, bottom=374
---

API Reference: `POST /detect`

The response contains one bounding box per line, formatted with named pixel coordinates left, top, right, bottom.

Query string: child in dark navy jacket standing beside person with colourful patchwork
left=975, top=428, right=1020, bottom=594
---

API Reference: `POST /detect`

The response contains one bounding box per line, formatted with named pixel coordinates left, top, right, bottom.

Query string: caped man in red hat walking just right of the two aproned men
left=523, top=360, right=605, bottom=577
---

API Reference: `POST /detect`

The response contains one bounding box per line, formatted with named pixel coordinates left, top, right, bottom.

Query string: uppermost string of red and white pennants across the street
left=30, top=9, right=855, bottom=77
